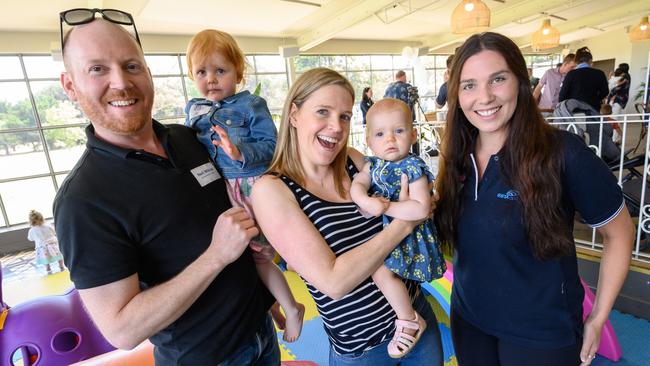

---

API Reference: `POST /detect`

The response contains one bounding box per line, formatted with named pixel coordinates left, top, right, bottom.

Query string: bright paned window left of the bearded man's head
left=0, top=55, right=86, bottom=226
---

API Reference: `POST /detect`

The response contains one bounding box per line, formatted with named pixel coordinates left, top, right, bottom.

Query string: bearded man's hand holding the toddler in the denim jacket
left=208, top=207, right=259, bottom=265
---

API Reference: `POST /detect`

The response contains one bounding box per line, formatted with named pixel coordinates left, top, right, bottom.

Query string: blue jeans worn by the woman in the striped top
left=330, top=290, right=443, bottom=366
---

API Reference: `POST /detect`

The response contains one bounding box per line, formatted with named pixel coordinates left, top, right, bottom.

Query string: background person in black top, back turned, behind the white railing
left=559, top=47, right=609, bottom=112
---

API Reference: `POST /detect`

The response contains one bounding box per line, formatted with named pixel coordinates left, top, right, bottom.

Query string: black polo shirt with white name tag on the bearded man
left=54, top=121, right=272, bottom=365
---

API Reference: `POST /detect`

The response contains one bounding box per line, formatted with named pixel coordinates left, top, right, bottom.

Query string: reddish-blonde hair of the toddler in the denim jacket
left=186, top=29, right=246, bottom=82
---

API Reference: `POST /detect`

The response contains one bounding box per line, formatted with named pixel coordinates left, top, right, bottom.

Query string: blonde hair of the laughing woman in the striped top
left=269, top=68, right=354, bottom=197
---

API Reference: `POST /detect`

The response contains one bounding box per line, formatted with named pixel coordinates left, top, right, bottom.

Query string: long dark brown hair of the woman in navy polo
left=435, top=32, right=574, bottom=260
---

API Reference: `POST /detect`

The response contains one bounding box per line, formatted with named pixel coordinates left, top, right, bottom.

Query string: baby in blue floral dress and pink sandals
left=350, top=98, right=446, bottom=358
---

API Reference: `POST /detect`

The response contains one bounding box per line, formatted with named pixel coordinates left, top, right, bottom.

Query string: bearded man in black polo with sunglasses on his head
left=54, top=9, right=280, bottom=365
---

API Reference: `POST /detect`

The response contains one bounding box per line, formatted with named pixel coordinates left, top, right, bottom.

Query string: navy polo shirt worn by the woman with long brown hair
left=451, top=131, right=624, bottom=348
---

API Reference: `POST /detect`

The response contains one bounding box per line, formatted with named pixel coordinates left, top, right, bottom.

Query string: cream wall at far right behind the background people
left=569, top=28, right=650, bottom=113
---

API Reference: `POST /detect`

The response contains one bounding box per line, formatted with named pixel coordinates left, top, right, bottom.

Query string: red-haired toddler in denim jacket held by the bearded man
left=185, top=29, right=305, bottom=342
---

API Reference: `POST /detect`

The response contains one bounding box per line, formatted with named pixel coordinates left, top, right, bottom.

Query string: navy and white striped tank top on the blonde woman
left=279, top=159, right=419, bottom=354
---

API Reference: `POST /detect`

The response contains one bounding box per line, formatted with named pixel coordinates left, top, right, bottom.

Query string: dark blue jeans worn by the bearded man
left=219, top=314, right=280, bottom=366
